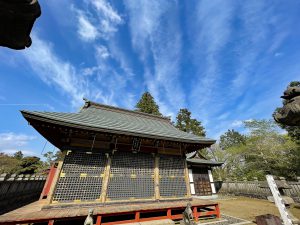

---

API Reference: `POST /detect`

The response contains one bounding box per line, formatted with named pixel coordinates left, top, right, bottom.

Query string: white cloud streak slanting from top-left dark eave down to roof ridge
left=24, top=34, right=121, bottom=108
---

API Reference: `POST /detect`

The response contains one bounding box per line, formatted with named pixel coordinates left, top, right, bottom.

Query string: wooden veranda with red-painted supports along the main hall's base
left=0, top=198, right=220, bottom=225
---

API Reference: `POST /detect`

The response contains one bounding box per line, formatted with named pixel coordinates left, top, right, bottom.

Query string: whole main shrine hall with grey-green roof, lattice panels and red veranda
left=0, top=100, right=220, bottom=225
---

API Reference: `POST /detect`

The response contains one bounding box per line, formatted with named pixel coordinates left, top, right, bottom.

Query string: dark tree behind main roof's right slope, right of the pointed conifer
left=175, top=108, right=205, bottom=137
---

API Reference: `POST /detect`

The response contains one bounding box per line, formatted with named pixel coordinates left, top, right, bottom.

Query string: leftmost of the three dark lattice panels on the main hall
left=53, top=152, right=107, bottom=202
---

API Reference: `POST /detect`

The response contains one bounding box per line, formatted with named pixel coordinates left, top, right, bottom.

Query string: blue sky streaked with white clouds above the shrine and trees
left=0, top=0, right=300, bottom=156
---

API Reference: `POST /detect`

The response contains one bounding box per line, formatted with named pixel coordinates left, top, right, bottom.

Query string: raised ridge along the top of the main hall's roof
left=81, top=98, right=171, bottom=123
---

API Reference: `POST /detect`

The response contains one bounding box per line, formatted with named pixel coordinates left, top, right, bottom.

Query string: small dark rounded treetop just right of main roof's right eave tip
left=220, top=129, right=246, bottom=149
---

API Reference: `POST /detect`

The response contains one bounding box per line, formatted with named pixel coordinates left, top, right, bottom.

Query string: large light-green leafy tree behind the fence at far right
left=243, top=120, right=299, bottom=178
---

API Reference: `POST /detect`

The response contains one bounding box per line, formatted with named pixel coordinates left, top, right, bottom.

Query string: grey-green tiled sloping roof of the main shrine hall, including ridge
left=21, top=100, right=215, bottom=146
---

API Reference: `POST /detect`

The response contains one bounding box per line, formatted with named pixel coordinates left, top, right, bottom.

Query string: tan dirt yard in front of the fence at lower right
left=218, top=197, right=300, bottom=221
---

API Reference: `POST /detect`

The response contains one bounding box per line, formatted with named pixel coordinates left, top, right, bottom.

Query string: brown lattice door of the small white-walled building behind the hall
left=193, top=168, right=212, bottom=196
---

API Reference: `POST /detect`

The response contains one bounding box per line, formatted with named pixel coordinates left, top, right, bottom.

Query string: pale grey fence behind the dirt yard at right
left=215, top=177, right=300, bottom=203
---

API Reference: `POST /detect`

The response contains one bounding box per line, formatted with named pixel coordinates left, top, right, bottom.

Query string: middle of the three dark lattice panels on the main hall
left=107, top=152, right=154, bottom=200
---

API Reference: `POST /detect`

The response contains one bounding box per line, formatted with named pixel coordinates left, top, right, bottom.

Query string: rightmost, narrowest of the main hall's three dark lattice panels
left=159, top=155, right=187, bottom=197
